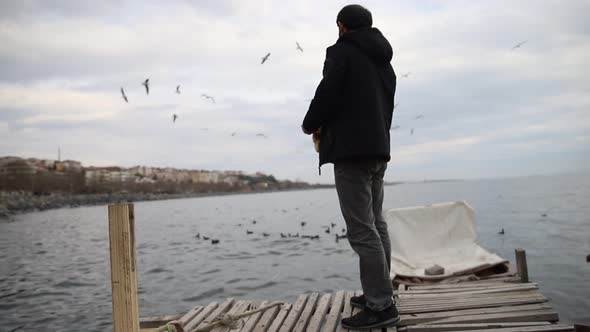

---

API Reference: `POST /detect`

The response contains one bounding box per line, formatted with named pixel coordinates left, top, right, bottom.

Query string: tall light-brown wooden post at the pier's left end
left=109, top=204, right=139, bottom=332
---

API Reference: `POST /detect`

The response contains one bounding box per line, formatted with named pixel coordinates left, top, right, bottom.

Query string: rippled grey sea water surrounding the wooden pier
left=0, top=175, right=590, bottom=331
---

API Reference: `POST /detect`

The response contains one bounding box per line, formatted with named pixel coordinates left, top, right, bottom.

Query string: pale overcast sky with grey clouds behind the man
left=0, top=0, right=590, bottom=183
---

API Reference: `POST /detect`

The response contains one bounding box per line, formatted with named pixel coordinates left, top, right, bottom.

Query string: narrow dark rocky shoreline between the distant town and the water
left=0, top=185, right=334, bottom=220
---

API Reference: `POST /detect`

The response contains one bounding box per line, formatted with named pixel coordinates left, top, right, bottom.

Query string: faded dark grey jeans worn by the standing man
left=334, top=160, right=393, bottom=311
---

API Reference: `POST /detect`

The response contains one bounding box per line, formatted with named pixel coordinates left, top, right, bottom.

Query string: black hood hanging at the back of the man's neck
left=337, top=28, right=393, bottom=64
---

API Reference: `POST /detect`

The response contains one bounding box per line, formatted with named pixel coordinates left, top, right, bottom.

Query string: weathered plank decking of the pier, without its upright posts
left=141, top=278, right=575, bottom=332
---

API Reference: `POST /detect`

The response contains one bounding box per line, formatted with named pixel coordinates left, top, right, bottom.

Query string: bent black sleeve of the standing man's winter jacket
left=303, top=47, right=346, bottom=131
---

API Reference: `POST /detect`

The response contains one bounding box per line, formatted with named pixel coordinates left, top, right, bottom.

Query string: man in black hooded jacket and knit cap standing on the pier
left=302, top=5, right=399, bottom=329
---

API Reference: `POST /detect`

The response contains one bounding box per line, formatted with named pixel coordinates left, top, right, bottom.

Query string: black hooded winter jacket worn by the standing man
left=303, top=28, right=396, bottom=166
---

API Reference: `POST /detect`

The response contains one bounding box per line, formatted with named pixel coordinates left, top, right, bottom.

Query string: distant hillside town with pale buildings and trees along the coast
left=0, top=157, right=321, bottom=195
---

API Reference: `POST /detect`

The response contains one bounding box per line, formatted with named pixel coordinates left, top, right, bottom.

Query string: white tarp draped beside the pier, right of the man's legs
left=384, top=202, right=507, bottom=280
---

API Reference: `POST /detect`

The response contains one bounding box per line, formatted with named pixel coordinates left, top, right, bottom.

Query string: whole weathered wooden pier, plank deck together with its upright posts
left=109, top=204, right=590, bottom=332
